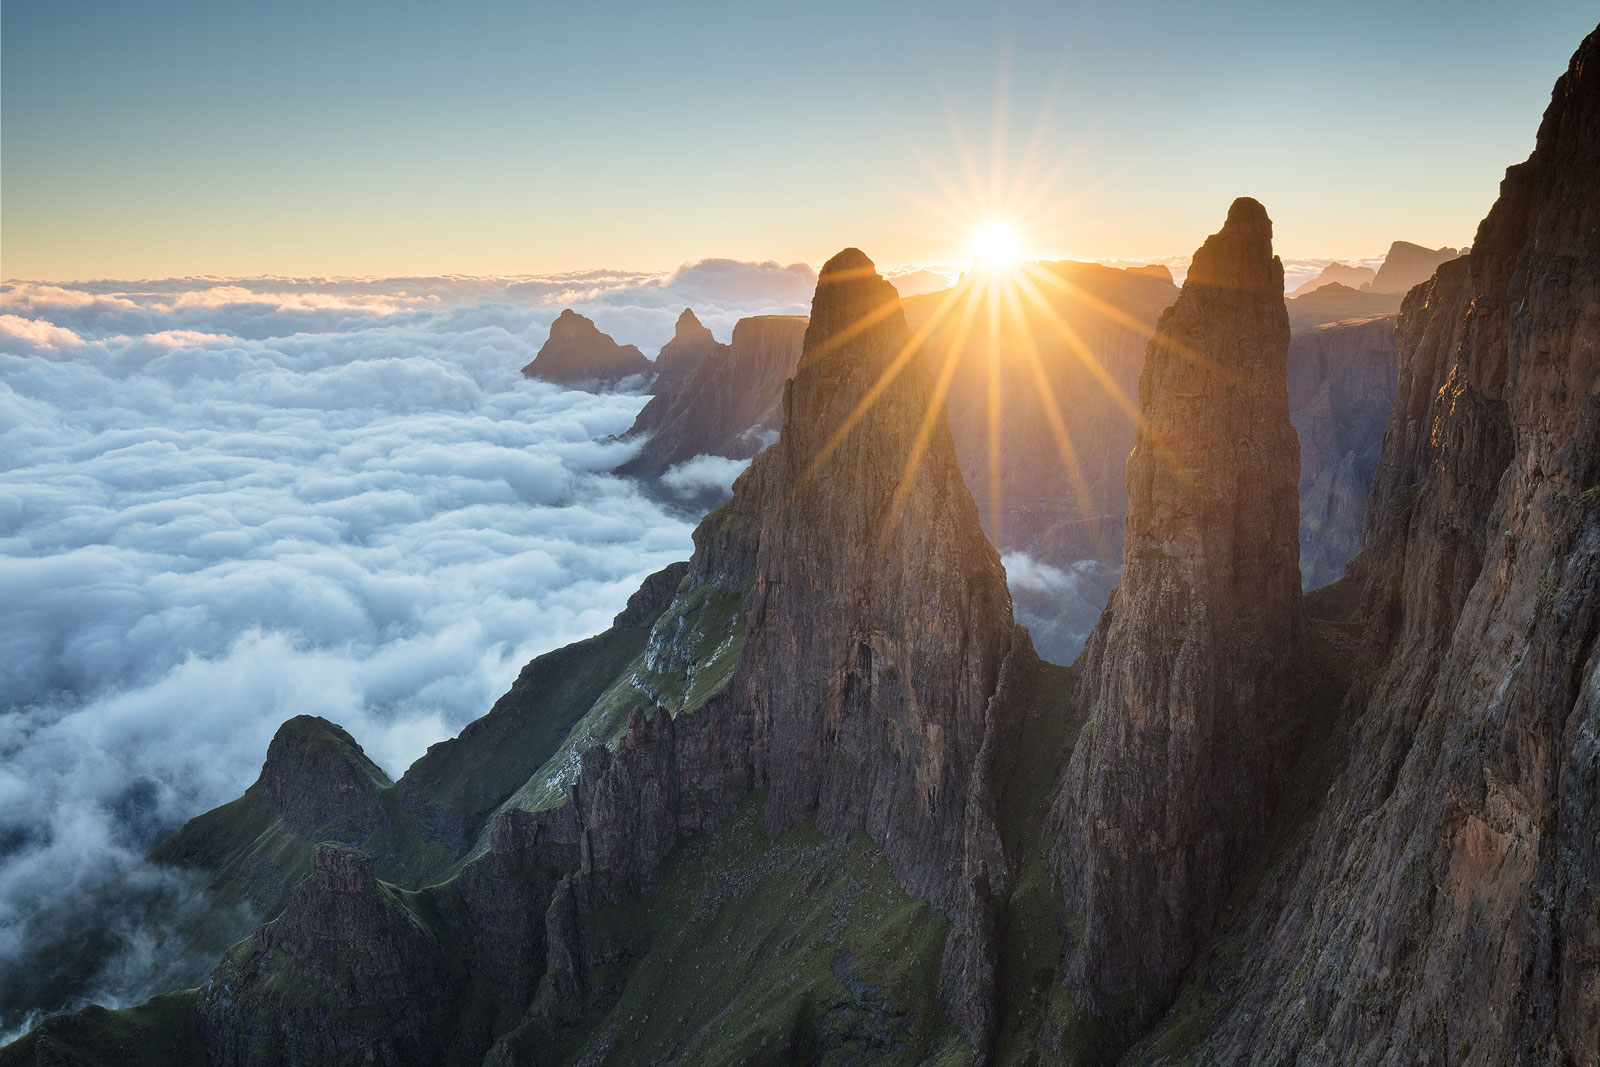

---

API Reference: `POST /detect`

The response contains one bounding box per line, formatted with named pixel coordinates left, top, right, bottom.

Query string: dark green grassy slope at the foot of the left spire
left=509, top=798, right=970, bottom=1067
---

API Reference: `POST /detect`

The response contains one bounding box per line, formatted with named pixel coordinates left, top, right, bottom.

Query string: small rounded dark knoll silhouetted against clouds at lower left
left=256, top=715, right=390, bottom=841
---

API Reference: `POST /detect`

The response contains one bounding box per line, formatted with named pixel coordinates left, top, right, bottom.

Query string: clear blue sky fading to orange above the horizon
left=9, top=0, right=1595, bottom=280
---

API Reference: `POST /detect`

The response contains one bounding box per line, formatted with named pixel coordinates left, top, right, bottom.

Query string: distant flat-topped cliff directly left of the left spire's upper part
left=618, top=315, right=806, bottom=478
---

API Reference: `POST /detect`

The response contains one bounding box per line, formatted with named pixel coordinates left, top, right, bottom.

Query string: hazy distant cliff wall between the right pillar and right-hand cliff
left=1288, top=315, right=1398, bottom=589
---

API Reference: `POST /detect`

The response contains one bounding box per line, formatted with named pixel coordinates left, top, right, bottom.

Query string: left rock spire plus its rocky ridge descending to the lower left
left=178, top=250, right=1037, bottom=1065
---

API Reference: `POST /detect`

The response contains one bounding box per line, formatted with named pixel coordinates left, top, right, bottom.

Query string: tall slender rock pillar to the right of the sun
left=1054, top=198, right=1306, bottom=1038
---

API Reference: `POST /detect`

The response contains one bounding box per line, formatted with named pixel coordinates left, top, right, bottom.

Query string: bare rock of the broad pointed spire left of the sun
left=733, top=248, right=1011, bottom=896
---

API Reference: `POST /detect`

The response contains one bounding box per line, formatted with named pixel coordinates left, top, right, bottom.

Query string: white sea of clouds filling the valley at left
left=0, top=261, right=876, bottom=1033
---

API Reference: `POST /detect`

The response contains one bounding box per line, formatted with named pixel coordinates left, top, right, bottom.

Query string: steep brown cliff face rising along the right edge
left=1152, top=22, right=1600, bottom=1065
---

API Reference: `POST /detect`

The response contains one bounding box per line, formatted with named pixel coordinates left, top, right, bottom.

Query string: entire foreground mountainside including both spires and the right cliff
left=0, top=18, right=1600, bottom=1067
